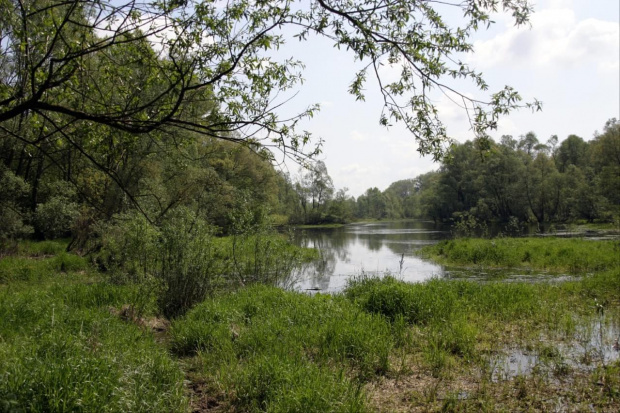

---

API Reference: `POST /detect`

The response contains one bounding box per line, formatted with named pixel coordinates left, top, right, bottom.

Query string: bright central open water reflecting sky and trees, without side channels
left=287, top=221, right=450, bottom=292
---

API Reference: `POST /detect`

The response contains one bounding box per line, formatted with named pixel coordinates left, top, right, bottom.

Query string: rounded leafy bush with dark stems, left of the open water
left=95, top=208, right=223, bottom=317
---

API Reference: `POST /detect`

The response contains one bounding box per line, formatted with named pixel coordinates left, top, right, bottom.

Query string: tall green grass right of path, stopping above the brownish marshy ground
left=171, top=269, right=620, bottom=411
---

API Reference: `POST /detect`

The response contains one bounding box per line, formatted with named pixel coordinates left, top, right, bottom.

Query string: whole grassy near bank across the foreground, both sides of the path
left=0, top=238, right=620, bottom=412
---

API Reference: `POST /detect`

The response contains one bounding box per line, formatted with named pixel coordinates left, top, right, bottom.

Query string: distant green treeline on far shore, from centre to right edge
left=281, top=119, right=620, bottom=229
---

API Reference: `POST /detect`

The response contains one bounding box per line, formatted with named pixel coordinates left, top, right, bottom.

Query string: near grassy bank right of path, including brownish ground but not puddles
left=171, top=270, right=620, bottom=412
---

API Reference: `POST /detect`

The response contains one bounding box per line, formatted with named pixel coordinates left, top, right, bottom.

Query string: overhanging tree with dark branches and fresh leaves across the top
left=0, top=0, right=539, bottom=172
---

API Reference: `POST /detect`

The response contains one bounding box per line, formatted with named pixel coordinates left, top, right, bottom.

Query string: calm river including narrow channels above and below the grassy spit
left=284, top=221, right=618, bottom=292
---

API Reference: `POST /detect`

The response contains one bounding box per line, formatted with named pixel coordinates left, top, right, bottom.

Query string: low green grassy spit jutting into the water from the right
left=420, top=238, right=620, bottom=274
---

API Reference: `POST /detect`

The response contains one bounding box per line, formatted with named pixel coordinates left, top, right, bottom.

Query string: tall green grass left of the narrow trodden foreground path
left=0, top=280, right=186, bottom=412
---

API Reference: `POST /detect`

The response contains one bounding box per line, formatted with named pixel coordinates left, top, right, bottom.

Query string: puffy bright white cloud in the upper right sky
left=469, top=7, right=620, bottom=71
